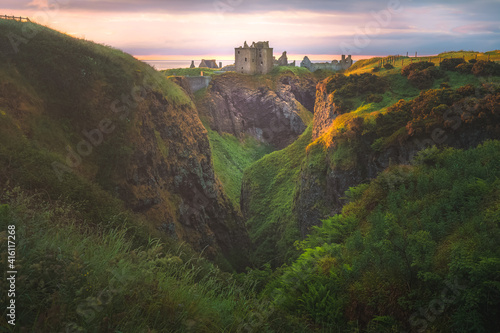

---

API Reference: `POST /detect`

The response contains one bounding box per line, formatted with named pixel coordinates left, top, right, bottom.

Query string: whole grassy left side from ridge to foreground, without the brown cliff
left=0, top=20, right=258, bottom=332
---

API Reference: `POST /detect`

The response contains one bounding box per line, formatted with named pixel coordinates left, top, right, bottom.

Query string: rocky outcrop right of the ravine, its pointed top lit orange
left=294, top=84, right=500, bottom=237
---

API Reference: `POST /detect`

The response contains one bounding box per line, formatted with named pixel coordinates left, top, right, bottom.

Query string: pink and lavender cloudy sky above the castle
left=0, top=0, right=500, bottom=60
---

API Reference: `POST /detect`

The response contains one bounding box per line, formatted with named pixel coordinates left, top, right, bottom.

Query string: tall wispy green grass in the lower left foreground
left=0, top=188, right=258, bottom=332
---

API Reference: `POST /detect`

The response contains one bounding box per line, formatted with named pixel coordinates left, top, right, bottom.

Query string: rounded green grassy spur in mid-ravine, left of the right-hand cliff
left=242, top=126, right=312, bottom=265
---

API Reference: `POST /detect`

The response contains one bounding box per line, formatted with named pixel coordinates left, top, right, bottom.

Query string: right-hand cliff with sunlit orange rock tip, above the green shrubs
left=294, top=83, right=500, bottom=236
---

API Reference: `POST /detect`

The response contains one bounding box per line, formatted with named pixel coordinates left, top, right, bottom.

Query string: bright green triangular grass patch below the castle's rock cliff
left=207, top=128, right=274, bottom=207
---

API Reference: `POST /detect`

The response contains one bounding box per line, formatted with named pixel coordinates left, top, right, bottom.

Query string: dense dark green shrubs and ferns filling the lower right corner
left=271, top=141, right=500, bottom=332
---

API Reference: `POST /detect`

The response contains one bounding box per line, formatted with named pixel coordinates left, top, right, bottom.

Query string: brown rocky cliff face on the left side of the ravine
left=119, top=91, right=249, bottom=265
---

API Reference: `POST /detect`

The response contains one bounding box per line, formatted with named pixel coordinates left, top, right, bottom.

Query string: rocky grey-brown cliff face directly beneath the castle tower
left=201, top=73, right=316, bottom=149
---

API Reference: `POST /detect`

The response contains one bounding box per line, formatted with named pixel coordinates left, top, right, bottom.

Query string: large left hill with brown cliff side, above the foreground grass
left=0, top=22, right=249, bottom=265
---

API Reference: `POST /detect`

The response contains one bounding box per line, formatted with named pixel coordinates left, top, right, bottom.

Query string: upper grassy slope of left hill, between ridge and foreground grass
left=0, top=20, right=200, bottom=228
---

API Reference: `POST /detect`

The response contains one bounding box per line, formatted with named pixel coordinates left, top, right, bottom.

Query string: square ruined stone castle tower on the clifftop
left=234, top=42, right=274, bottom=74
